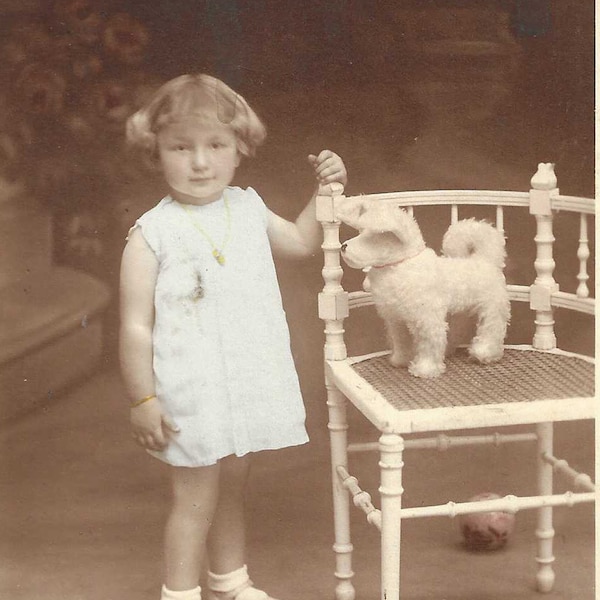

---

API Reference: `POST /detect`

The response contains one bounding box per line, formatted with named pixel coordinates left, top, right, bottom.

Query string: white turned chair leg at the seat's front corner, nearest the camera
left=379, top=433, right=404, bottom=600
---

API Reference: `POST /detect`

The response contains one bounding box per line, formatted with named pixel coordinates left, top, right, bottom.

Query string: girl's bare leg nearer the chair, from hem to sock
left=208, top=455, right=250, bottom=574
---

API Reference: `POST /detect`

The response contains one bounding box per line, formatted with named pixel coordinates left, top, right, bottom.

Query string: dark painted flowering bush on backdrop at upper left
left=0, top=0, right=157, bottom=272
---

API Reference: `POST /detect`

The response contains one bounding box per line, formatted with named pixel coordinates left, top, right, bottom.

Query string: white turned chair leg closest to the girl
left=327, top=387, right=356, bottom=600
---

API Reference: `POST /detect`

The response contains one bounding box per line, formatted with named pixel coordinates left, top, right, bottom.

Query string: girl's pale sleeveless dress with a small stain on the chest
left=134, top=187, right=308, bottom=467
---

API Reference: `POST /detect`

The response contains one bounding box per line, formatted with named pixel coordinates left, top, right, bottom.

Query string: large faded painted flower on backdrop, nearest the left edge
left=14, top=63, right=66, bottom=115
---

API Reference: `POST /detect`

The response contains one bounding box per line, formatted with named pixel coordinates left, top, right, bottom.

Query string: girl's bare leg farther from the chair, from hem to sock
left=165, top=464, right=220, bottom=591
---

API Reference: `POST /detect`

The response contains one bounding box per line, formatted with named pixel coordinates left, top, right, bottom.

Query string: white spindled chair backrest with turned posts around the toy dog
left=317, top=163, right=595, bottom=360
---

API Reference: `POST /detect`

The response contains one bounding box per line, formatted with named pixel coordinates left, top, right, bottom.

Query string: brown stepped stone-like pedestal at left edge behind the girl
left=0, top=181, right=110, bottom=422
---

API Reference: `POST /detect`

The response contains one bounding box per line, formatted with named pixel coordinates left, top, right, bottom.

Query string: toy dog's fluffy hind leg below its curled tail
left=469, top=296, right=510, bottom=364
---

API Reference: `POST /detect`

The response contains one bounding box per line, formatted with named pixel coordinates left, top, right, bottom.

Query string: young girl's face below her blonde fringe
left=157, top=117, right=240, bottom=205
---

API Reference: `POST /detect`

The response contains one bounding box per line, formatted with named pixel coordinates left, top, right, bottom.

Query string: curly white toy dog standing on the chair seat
left=340, top=202, right=510, bottom=377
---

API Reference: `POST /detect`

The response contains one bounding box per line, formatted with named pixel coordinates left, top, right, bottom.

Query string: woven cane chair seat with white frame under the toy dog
left=327, top=346, right=595, bottom=434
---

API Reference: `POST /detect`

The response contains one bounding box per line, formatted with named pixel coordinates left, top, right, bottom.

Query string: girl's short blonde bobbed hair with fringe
left=126, top=74, right=267, bottom=157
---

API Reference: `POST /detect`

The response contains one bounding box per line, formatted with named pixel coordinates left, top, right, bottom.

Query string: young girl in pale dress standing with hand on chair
left=120, top=75, right=346, bottom=600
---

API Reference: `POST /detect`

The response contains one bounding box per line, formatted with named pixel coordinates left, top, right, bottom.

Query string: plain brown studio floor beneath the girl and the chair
left=0, top=370, right=595, bottom=600
